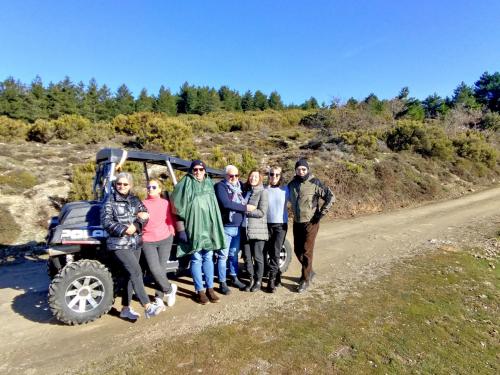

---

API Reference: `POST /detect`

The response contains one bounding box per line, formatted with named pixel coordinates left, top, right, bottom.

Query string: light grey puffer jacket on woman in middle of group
left=247, top=185, right=269, bottom=241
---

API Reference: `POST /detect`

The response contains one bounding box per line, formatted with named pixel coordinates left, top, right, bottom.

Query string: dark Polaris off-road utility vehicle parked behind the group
left=46, top=148, right=292, bottom=325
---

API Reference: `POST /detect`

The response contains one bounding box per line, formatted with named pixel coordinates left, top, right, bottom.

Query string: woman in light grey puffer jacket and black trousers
left=241, top=170, right=269, bottom=292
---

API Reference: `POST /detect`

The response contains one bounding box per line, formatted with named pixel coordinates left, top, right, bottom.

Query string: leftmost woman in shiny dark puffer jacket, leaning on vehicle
left=101, top=173, right=162, bottom=320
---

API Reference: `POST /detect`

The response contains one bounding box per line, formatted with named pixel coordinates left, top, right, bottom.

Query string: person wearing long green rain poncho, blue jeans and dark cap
left=172, top=160, right=225, bottom=305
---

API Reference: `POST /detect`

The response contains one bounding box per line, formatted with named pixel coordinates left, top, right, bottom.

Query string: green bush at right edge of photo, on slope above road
left=453, top=131, right=498, bottom=168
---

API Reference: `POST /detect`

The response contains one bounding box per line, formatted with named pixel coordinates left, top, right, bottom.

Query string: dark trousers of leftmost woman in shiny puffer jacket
left=113, top=248, right=150, bottom=306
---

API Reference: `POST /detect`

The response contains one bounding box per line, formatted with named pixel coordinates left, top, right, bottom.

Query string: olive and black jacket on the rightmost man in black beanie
left=288, top=175, right=335, bottom=223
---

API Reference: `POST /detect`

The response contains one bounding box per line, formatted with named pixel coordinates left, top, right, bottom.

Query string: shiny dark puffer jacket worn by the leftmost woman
left=101, top=192, right=148, bottom=250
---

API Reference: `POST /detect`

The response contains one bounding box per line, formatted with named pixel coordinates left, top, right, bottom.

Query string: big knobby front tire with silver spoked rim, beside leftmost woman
left=49, top=259, right=114, bottom=325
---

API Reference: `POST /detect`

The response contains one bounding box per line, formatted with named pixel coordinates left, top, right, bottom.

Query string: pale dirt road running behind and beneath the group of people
left=0, top=188, right=500, bottom=374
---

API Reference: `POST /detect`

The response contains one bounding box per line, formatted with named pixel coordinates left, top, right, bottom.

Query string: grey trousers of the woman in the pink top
left=142, top=236, right=174, bottom=298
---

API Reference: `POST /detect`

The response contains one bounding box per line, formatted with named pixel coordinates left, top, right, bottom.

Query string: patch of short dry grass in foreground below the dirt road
left=96, top=242, right=500, bottom=374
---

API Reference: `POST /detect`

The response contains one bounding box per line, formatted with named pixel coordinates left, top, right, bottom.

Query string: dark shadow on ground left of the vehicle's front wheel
left=0, top=243, right=61, bottom=325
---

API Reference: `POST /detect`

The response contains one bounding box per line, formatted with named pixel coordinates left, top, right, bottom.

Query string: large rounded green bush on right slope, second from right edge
left=386, top=120, right=454, bottom=160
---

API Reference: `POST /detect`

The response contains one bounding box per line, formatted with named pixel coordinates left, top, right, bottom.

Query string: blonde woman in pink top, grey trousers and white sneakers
left=142, top=179, right=177, bottom=311
